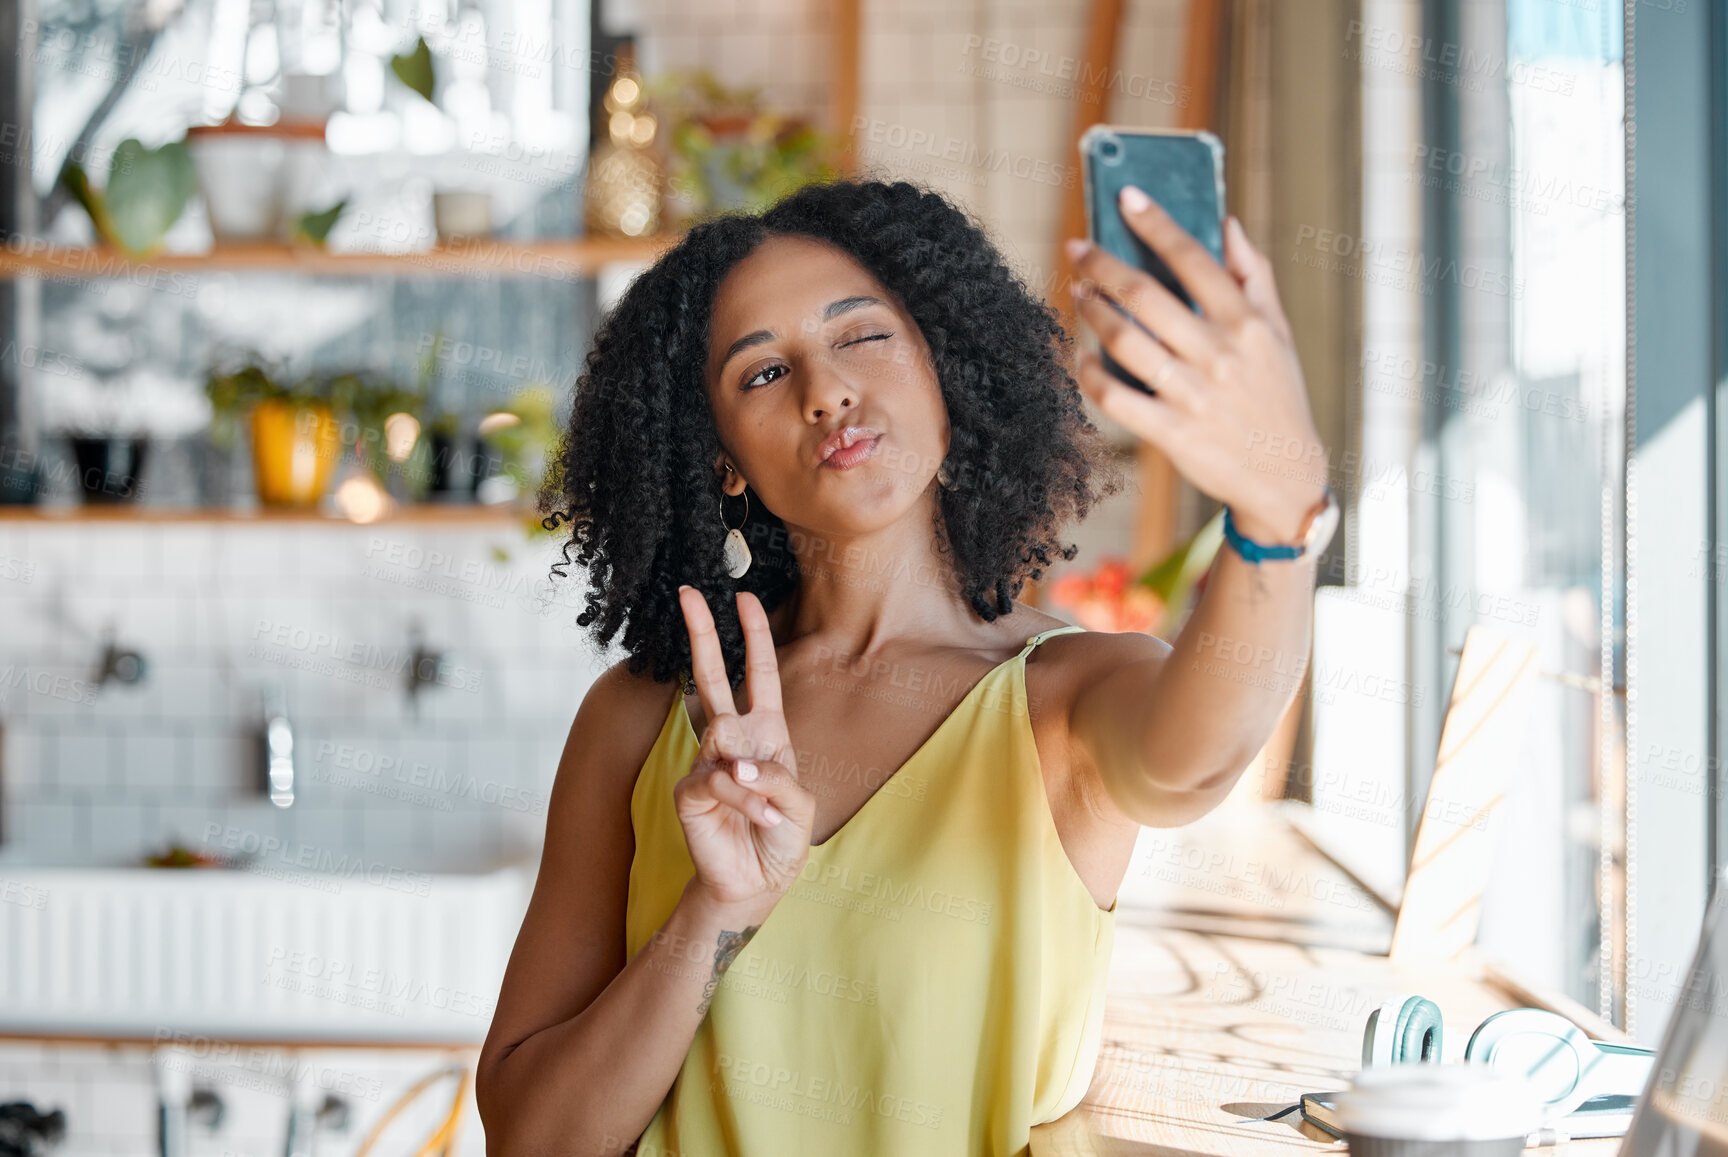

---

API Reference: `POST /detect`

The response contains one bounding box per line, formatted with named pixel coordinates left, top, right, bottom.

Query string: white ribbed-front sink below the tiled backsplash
left=0, top=865, right=534, bottom=1045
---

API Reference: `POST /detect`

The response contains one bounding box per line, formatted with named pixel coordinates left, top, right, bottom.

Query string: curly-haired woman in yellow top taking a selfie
left=477, top=183, right=1336, bottom=1157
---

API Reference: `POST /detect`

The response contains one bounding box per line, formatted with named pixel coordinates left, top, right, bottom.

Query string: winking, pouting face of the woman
left=707, top=237, right=949, bottom=537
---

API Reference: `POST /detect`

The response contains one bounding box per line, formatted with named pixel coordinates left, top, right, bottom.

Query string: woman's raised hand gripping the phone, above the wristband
left=1068, top=187, right=1327, bottom=542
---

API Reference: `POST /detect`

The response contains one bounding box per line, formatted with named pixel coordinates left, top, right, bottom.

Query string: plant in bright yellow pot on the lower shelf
left=204, top=359, right=342, bottom=508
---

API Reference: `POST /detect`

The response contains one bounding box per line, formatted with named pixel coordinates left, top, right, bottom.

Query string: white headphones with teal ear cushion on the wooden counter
left=1362, top=996, right=1655, bottom=1119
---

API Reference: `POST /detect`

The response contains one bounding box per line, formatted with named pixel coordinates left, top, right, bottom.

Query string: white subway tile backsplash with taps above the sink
left=0, top=516, right=610, bottom=870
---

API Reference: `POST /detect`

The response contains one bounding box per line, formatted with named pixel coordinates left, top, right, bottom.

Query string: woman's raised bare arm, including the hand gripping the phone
left=1071, top=190, right=1327, bottom=827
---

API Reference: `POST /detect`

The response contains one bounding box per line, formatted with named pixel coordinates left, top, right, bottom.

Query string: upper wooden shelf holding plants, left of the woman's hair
left=0, top=233, right=679, bottom=281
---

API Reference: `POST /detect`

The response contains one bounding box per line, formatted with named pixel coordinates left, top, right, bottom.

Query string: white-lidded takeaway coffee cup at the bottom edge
left=1337, top=1064, right=1541, bottom=1157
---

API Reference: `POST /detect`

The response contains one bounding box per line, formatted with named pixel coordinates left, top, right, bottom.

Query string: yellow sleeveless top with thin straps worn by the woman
left=626, top=627, right=1116, bottom=1157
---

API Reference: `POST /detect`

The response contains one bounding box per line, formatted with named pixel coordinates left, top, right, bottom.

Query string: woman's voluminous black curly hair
left=539, top=181, right=1123, bottom=689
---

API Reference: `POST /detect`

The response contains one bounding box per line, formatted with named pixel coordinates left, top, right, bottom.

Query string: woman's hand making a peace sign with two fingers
left=672, top=587, right=816, bottom=915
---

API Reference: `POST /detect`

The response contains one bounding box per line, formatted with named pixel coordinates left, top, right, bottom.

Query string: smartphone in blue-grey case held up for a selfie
left=1080, top=124, right=1223, bottom=394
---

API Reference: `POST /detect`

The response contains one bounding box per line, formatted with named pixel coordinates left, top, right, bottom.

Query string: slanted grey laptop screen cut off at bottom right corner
left=1619, top=877, right=1728, bottom=1157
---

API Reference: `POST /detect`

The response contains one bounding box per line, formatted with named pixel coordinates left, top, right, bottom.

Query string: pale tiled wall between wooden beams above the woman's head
left=636, top=0, right=1189, bottom=305
